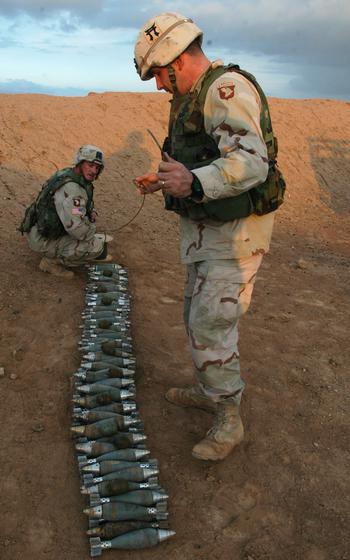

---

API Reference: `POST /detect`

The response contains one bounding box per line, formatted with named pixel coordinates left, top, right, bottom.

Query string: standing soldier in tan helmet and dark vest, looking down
left=135, top=13, right=285, bottom=461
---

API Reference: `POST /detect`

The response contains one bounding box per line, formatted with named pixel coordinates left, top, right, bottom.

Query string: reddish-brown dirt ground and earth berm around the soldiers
left=0, top=93, right=350, bottom=560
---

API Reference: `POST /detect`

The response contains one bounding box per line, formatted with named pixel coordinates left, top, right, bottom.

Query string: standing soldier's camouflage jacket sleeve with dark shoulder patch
left=192, top=72, right=268, bottom=202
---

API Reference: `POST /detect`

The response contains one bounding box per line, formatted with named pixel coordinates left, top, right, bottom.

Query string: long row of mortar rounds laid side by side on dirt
left=71, top=263, right=175, bottom=557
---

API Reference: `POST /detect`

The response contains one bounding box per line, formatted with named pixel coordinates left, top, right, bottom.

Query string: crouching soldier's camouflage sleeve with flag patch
left=54, top=182, right=96, bottom=241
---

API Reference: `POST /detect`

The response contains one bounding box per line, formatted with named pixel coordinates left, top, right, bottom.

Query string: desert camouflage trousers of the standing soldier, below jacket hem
left=184, top=255, right=262, bottom=405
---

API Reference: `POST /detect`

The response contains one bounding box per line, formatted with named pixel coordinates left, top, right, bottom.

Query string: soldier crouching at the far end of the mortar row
left=19, top=144, right=112, bottom=278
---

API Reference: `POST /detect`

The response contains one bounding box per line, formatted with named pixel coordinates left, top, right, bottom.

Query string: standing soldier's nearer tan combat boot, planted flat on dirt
left=192, top=401, right=244, bottom=461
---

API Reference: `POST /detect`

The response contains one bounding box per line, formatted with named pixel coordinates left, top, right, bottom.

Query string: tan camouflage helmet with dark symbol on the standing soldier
left=134, top=12, right=203, bottom=80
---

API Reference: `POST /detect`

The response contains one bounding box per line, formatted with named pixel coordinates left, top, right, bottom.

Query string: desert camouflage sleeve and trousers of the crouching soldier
left=28, top=182, right=104, bottom=267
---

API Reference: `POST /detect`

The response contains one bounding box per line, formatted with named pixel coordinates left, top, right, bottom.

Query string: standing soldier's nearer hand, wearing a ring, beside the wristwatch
left=158, top=152, right=193, bottom=198
